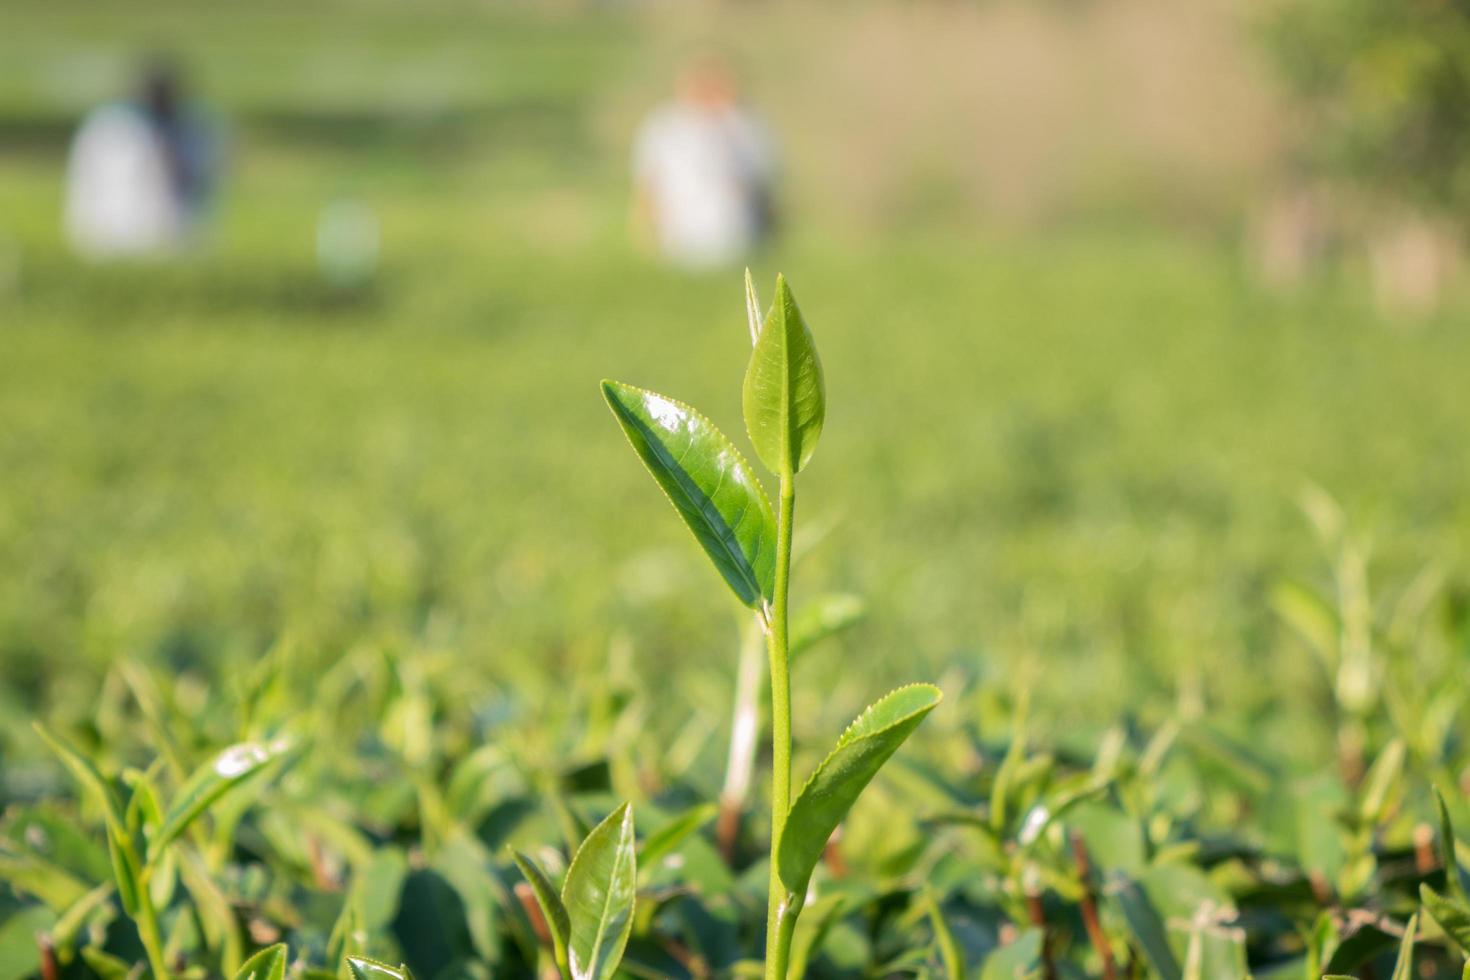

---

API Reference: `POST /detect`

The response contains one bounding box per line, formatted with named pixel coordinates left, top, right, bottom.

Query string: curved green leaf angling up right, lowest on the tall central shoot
left=776, top=685, right=942, bottom=895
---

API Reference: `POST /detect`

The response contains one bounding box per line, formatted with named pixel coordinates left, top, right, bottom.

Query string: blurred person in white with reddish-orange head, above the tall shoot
left=634, top=54, right=776, bottom=267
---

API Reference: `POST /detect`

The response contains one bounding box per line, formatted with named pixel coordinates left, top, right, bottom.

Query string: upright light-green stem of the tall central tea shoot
left=766, top=473, right=801, bottom=980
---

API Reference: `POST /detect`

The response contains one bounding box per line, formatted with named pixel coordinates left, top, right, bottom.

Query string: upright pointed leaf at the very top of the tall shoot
left=741, top=276, right=826, bottom=476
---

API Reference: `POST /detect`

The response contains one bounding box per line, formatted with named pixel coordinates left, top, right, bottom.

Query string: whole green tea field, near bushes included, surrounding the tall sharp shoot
left=0, top=3, right=1470, bottom=980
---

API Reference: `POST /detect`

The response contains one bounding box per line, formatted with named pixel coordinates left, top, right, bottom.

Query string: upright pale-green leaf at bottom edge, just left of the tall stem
left=562, top=804, right=638, bottom=980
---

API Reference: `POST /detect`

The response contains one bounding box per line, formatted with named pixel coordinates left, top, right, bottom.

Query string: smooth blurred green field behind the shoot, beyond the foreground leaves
left=0, top=0, right=1470, bottom=760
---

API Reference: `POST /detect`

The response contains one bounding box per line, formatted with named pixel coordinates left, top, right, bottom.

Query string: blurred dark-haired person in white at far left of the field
left=65, top=57, right=219, bottom=259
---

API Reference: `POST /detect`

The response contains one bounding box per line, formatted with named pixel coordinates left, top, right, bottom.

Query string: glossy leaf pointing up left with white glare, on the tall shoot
left=603, top=381, right=776, bottom=608
